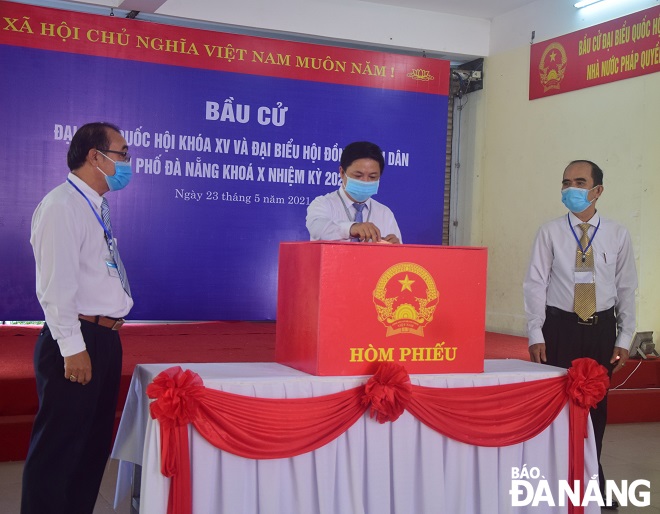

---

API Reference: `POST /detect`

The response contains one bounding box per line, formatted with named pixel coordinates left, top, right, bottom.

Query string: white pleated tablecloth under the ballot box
left=112, top=360, right=600, bottom=514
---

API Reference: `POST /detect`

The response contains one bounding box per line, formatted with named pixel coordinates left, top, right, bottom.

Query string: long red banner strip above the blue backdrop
left=0, top=1, right=449, bottom=95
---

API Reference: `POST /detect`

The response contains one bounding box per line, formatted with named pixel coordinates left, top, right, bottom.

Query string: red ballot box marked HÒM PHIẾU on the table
left=275, top=242, right=487, bottom=375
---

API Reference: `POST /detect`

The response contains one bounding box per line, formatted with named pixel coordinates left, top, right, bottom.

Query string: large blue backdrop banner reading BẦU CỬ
left=0, top=2, right=447, bottom=320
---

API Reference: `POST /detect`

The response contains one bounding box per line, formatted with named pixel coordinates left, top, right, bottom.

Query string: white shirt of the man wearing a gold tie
left=523, top=213, right=637, bottom=349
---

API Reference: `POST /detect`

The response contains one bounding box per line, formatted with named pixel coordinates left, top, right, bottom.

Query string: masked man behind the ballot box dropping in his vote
left=307, top=141, right=401, bottom=243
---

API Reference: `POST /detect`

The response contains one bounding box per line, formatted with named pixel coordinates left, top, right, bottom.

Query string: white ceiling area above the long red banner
left=41, top=0, right=552, bottom=62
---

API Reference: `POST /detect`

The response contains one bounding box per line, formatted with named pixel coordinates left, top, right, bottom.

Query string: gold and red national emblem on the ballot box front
left=373, top=262, right=438, bottom=337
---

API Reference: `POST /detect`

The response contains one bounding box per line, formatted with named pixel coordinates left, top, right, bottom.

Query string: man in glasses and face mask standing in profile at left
left=21, top=123, right=133, bottom=514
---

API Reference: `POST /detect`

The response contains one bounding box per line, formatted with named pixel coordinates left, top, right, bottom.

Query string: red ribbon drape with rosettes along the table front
left=147, top=358, right=609, bottom=514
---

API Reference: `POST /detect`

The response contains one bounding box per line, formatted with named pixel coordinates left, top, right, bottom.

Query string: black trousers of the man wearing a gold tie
left=543, top=307, right=616, bottom=490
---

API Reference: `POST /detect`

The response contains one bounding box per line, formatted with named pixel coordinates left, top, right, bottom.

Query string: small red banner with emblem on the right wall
left=529, top=6, right=660, bottom=100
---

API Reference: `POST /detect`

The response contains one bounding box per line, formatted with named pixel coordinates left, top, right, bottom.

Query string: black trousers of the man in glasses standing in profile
left=21, top=321, right=122, bottom=514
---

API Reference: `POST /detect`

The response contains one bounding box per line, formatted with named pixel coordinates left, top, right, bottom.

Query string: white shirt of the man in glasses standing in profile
left=30, top=173, right=133, bottom=357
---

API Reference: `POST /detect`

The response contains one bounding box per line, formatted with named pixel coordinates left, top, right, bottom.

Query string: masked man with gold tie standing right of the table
left=523, top=160, right=637, bottom=507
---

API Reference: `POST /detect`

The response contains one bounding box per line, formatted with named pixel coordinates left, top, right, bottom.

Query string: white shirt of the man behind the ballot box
left=306, top=187, right=403, bottom=242
